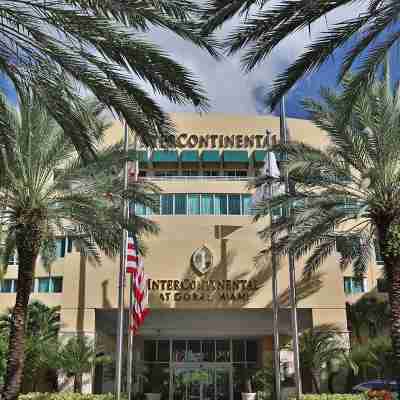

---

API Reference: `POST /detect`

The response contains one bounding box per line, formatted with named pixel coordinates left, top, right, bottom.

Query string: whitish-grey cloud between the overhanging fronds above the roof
left=145, top=1, right=366, bottom=114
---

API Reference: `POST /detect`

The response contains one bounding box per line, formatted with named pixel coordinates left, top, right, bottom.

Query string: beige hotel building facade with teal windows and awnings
left=0, top=113, right=381, bottom=400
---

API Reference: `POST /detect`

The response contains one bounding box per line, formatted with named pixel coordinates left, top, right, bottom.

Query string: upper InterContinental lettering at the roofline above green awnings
left=160, top=133, right=277, bottom=149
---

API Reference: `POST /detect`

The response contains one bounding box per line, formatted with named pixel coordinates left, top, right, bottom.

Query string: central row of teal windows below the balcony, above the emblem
left=135, top=193, right=251, bottom=216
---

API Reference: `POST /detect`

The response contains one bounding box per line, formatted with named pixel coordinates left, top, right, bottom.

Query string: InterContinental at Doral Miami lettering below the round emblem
left=147, top=279, right=258, bottom=302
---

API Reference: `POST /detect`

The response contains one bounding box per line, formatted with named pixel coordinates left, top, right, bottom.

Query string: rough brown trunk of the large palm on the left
left=2, top=224, right=41, bottom=400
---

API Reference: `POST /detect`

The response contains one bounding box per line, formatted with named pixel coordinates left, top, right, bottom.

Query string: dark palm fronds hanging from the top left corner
left=0, top=0, right=217, bottom=157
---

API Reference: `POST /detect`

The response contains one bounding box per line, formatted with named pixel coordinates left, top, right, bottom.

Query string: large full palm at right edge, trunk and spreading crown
left=255, top=76, right=400, bottom=367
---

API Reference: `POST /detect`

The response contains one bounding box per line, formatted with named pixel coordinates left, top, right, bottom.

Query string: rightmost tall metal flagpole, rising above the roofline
left=280, top=96, right=302, bottom=400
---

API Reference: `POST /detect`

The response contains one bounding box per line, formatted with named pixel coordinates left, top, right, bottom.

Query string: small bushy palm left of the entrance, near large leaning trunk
left=57, top=335, right=110, bottom=393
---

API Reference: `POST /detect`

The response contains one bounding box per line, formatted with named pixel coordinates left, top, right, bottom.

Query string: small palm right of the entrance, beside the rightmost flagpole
left=299, top=325, right=347, bottom=393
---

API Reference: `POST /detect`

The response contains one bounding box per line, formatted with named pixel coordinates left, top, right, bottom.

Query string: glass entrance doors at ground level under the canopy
left=170, top=363, right=231, bottom=400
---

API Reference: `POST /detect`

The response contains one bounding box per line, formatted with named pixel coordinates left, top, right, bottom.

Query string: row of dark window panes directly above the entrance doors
left=144, top=339, right=258, bottom=363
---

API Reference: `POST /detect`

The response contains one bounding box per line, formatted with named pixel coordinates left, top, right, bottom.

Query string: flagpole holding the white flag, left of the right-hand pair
left=267, top=131, right=281, bottom=400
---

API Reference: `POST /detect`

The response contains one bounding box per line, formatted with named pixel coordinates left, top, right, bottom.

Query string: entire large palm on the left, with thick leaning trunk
left=0, top=88, right=157, bottom=400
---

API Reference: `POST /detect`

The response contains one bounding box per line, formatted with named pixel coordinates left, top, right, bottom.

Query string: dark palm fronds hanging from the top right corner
left=203, top=0, right=400, bottom=107
